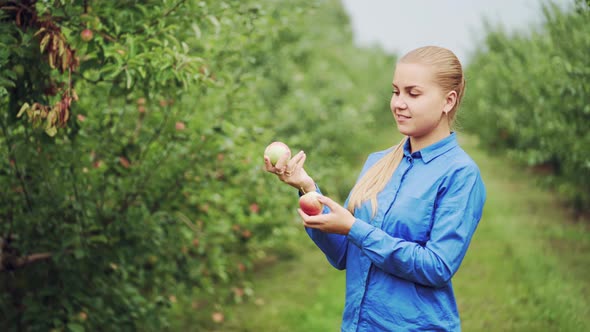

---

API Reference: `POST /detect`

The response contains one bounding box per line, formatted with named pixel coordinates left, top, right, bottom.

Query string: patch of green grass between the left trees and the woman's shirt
left=218, top=236, right=345, bottom=332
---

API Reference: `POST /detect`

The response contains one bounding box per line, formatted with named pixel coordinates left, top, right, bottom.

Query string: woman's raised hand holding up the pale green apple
left=264, top=151, right=315, bottom=192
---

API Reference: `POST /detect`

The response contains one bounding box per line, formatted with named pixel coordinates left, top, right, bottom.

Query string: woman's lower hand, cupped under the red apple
left=297, top=196, right=356, bottom=235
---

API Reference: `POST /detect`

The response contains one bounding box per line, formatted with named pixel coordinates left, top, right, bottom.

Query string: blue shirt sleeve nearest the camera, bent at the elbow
left=348, top=166, right=486, bottom=287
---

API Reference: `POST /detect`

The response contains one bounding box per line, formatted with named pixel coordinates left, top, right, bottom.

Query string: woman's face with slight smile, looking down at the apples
left=390, top=63, right=456, bottom=146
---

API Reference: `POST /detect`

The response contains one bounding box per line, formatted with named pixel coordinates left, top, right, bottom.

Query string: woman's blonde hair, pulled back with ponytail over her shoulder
left=348, top=46, right=465, bottom=216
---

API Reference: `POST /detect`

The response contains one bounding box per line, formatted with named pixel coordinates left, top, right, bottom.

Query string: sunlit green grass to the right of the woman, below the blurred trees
left=454, top=134, right=590, bottom=331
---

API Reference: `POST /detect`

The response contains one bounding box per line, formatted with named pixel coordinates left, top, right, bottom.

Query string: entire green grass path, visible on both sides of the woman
left=218, top=136, right=590, bottom=332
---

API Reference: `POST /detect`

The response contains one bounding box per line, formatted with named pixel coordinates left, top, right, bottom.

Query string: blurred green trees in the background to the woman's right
left=464, top=1, right=590, bottom=211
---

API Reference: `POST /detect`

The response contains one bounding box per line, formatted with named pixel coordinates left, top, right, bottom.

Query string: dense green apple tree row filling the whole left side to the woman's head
left=0, top=0, right=393, bottom=331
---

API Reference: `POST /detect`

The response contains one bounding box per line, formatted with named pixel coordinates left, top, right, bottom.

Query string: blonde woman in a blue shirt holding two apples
left=264, top=46, right=486, bottom=331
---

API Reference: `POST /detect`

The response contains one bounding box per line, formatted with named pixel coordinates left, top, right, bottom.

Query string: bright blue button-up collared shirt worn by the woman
left=306, top=133, right=486, bottom=332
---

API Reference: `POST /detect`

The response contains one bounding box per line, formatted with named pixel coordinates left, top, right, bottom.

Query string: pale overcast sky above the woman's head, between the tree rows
left=342, top=0, right=574, bottom=65
